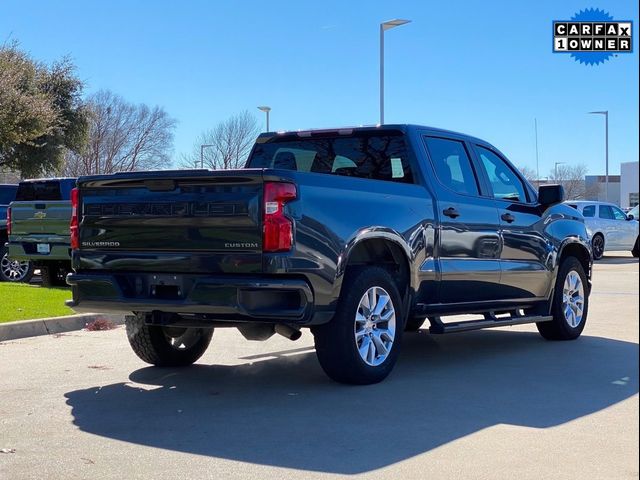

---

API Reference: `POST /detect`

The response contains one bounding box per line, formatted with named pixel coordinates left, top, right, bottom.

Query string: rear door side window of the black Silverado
left=425, top=137, right=479, bottom=195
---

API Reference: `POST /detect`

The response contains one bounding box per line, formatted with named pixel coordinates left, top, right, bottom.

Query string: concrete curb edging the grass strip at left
left=0, top=313, right=124, bottom=342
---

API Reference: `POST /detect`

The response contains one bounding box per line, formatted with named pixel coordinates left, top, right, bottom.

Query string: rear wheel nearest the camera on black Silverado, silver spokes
left=312, top=267, right=403, bottom=385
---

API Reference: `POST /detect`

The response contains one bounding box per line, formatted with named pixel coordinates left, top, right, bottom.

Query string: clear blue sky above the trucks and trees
left=0, top=0, right=638, bottom=177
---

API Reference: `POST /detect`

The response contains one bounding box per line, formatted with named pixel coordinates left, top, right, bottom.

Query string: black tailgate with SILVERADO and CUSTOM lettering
left=74, top=169, right=263, bottom=273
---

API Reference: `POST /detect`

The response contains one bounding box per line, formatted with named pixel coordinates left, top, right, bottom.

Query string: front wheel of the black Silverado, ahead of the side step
left=536, top=257, right=589, bottom=340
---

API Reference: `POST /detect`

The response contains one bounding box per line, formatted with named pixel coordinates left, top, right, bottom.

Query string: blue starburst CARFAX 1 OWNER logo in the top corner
left=553, top=8, right=633, bottom=65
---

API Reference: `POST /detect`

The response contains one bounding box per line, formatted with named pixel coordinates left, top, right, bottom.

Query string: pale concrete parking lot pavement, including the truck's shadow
left=0, top=254, right=639, bottom=480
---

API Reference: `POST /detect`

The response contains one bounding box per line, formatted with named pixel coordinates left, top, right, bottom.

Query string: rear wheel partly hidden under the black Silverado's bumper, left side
left=126, top=315, right=213, bottom=367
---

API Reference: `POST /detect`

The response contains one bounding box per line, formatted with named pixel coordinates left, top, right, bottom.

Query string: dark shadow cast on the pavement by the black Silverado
left=65, top=331, right=638, bottom=474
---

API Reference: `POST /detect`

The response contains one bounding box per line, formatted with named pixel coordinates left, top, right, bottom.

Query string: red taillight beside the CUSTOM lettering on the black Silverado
left=262, top=182, right=297, bottom=252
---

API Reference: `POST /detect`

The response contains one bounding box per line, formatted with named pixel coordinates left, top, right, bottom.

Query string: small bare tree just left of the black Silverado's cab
left=180, top=110, right=259, bottom=170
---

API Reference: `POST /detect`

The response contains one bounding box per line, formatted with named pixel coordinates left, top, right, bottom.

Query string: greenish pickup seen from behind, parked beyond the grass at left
left=7, top=178, right=76, bottom=286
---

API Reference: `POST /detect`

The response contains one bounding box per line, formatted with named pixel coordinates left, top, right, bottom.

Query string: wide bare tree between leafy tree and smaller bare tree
left=61, top=90, right=176, bottom=176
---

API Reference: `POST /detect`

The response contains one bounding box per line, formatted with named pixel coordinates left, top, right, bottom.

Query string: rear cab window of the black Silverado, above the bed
left=246, top=130, right=414, bottom=183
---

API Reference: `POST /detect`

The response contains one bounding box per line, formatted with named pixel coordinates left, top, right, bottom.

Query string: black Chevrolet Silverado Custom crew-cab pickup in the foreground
left=67, top=125, right=592, bottom=384
